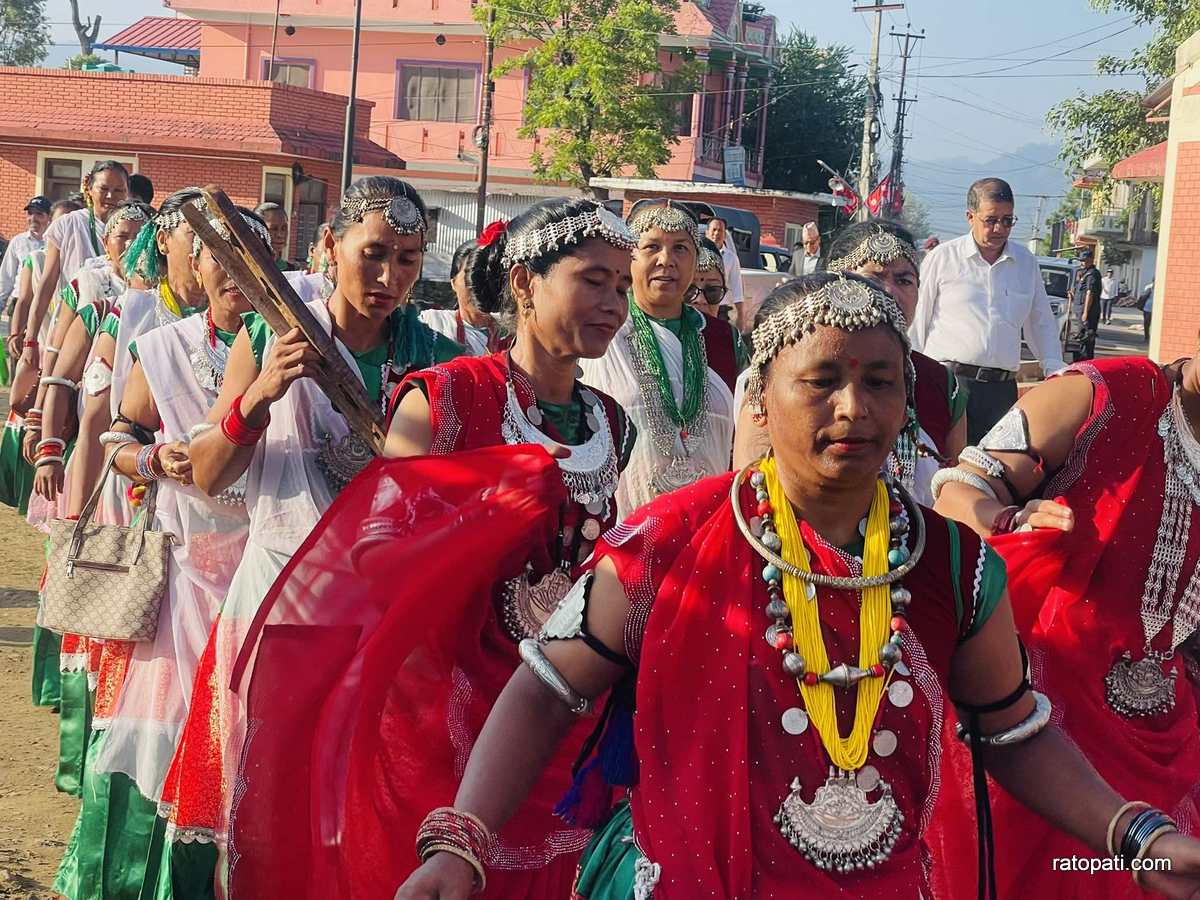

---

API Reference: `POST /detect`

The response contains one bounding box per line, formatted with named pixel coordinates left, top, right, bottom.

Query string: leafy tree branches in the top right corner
left=1046, top=0, right=1200, bottom=197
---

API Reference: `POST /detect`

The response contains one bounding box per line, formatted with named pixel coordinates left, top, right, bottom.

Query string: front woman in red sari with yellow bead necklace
left=397, top=275, right=1200, bottom=900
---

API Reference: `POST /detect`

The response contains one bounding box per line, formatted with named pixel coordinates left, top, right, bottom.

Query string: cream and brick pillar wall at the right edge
left=1150, top=32, right=1200, bottom=362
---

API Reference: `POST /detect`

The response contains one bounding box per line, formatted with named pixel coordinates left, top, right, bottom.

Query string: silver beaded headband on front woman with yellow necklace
left=746, top=276, right=916, bottom=409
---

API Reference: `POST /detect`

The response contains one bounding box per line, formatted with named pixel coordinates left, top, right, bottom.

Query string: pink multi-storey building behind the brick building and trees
left=104, top=0, right=776, bottom=277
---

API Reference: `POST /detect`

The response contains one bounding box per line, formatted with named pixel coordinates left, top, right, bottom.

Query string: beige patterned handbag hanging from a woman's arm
left=37, top=445, right=175, bottom=641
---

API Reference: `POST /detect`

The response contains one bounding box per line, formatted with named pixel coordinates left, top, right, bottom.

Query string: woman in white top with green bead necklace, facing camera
left=580, top=200, right=744, bottom=517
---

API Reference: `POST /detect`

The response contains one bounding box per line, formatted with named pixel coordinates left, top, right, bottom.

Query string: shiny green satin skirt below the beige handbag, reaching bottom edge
left=54, top=732, right=167, bottom=900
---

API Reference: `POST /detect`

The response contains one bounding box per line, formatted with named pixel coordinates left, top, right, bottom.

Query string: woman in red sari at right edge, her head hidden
left=935, top=358, right=1200, bottom=900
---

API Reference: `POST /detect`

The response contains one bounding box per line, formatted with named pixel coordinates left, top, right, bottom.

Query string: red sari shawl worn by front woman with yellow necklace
left=596, top=474, right=980, bottom=900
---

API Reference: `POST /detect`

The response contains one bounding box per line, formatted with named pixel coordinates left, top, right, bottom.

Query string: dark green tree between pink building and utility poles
left=763, top=29, right=866, bottom=193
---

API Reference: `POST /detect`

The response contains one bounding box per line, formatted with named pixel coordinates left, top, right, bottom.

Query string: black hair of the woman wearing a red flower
left=467, top=197, right=596, bottom=317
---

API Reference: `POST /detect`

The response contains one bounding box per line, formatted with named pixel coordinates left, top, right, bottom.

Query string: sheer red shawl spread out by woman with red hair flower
left=229, top=446, right=582, bottom=900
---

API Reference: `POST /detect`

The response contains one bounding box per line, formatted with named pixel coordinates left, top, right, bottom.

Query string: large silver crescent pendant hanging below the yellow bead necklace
left=775, top=767, right=904, bottom=872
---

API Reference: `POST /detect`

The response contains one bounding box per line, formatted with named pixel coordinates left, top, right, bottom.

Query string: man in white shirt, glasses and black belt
left=908, top=178, right=1066, bottom=444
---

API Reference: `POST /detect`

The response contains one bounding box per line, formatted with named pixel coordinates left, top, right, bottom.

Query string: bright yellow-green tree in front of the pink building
left=475, top=0, right=700, bottom=194
